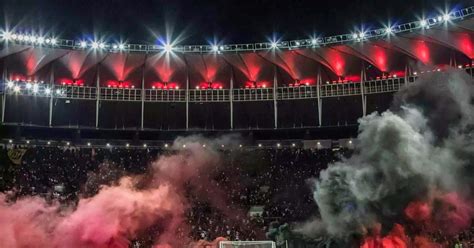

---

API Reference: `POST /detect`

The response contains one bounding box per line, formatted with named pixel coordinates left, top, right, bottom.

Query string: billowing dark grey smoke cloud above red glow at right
left=304, top=69, right=474, bottom=237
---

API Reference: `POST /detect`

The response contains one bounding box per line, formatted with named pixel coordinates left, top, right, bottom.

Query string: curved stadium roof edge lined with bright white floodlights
left=2, top=6, right=474, bottom=53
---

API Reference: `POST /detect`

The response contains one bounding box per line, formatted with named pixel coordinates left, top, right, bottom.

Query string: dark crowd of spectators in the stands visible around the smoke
left=0, top=143, right=474, bottom=248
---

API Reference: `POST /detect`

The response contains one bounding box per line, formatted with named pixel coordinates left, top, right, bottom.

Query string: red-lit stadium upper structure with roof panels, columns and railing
left=0, top=7, right=474, bottom=141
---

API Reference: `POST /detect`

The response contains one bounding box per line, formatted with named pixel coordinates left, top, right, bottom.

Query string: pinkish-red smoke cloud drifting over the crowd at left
left=0, top=144, right=238, bottom=248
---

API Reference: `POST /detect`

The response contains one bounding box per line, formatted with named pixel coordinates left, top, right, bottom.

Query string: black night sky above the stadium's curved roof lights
left=0, top=0, right=474, bottom=44
